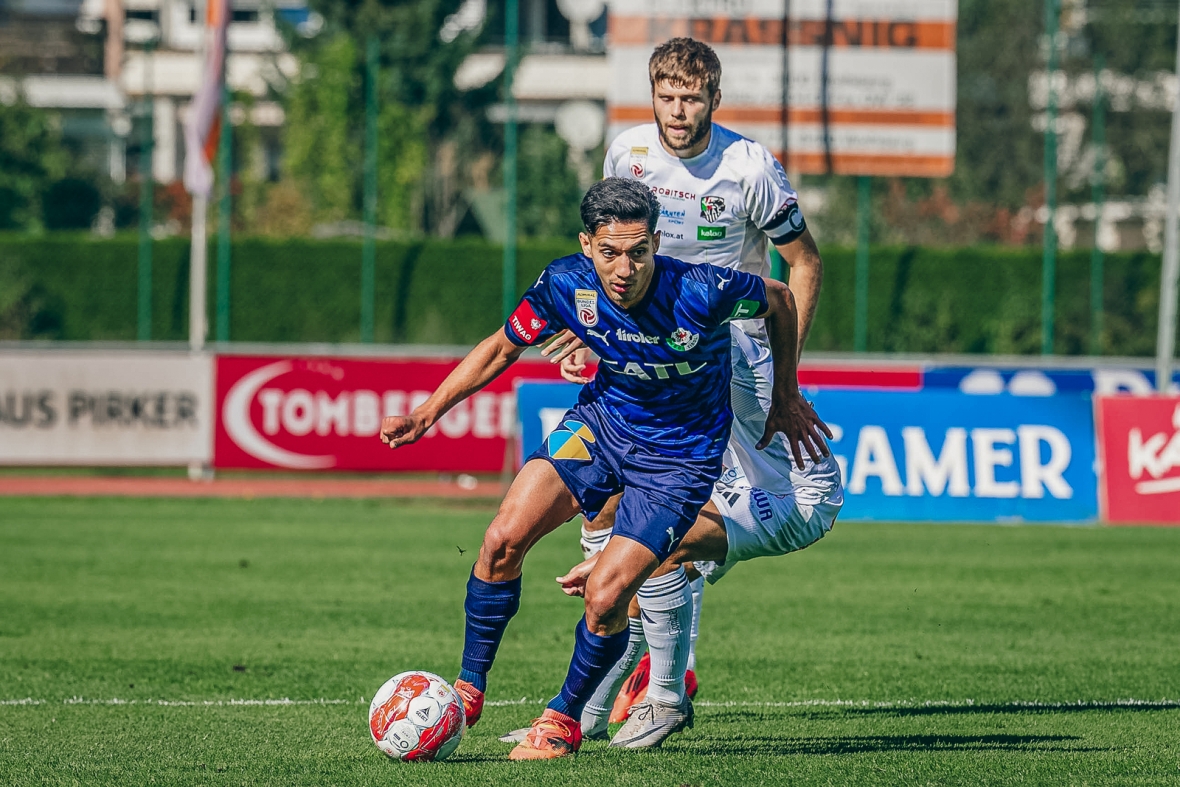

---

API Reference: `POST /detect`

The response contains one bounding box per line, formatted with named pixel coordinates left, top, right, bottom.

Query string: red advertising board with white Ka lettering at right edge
left=1096, top=396, right=1180, bottom=525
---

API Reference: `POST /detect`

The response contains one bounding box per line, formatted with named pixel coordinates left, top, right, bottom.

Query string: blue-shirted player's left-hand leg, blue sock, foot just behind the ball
left=455, top=459, right=578, bottom=727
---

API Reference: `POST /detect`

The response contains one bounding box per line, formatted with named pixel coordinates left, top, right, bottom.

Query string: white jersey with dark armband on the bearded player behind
left=602, top=123, right=816, bottom=497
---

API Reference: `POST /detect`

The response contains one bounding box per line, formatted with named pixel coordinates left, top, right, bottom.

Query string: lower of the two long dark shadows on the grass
left=679, top=735, right=1104, bottom=756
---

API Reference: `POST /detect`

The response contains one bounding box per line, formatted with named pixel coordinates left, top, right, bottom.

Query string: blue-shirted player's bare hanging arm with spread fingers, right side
left=755, top=278, right=832, bottom=470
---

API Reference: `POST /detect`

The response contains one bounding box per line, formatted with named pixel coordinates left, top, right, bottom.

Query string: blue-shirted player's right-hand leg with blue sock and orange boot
left=509, top=528, right=661, bottom=760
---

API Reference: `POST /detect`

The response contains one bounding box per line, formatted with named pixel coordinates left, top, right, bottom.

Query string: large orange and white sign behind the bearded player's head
left=608, top=0, right=958, bottom=177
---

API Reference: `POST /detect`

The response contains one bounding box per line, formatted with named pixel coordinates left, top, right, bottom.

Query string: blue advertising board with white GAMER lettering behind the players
left=517, top=382, right=1099, bottom=523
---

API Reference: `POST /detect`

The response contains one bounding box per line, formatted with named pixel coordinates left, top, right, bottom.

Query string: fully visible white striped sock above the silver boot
left=638, top=568, right=693, bottom=706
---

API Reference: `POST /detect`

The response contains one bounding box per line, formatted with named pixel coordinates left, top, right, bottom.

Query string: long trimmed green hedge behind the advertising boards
left=0, top=235, right=1160, bottom=355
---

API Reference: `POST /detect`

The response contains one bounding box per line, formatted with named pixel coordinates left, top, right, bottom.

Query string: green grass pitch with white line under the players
left=0, top=499, right=1180, bottom=787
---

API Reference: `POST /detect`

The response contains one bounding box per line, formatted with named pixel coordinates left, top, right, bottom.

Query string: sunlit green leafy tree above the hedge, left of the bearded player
left=286, top=0, right=496, bottom=234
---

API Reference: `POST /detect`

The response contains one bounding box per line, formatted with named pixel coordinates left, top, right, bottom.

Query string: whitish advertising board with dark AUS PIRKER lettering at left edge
left=0, top=350, right=214, bottom=466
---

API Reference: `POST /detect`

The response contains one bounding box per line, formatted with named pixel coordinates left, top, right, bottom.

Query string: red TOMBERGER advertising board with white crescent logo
left=214, top=355, right=559, bottom=473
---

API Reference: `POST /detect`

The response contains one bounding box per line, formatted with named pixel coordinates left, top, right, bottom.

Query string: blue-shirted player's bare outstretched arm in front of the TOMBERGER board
left=381, top=330, right=526, bottom=448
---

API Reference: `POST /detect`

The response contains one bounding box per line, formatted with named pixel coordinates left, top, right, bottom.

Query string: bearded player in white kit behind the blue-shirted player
left=495, top=39, right=843, bottom=748
